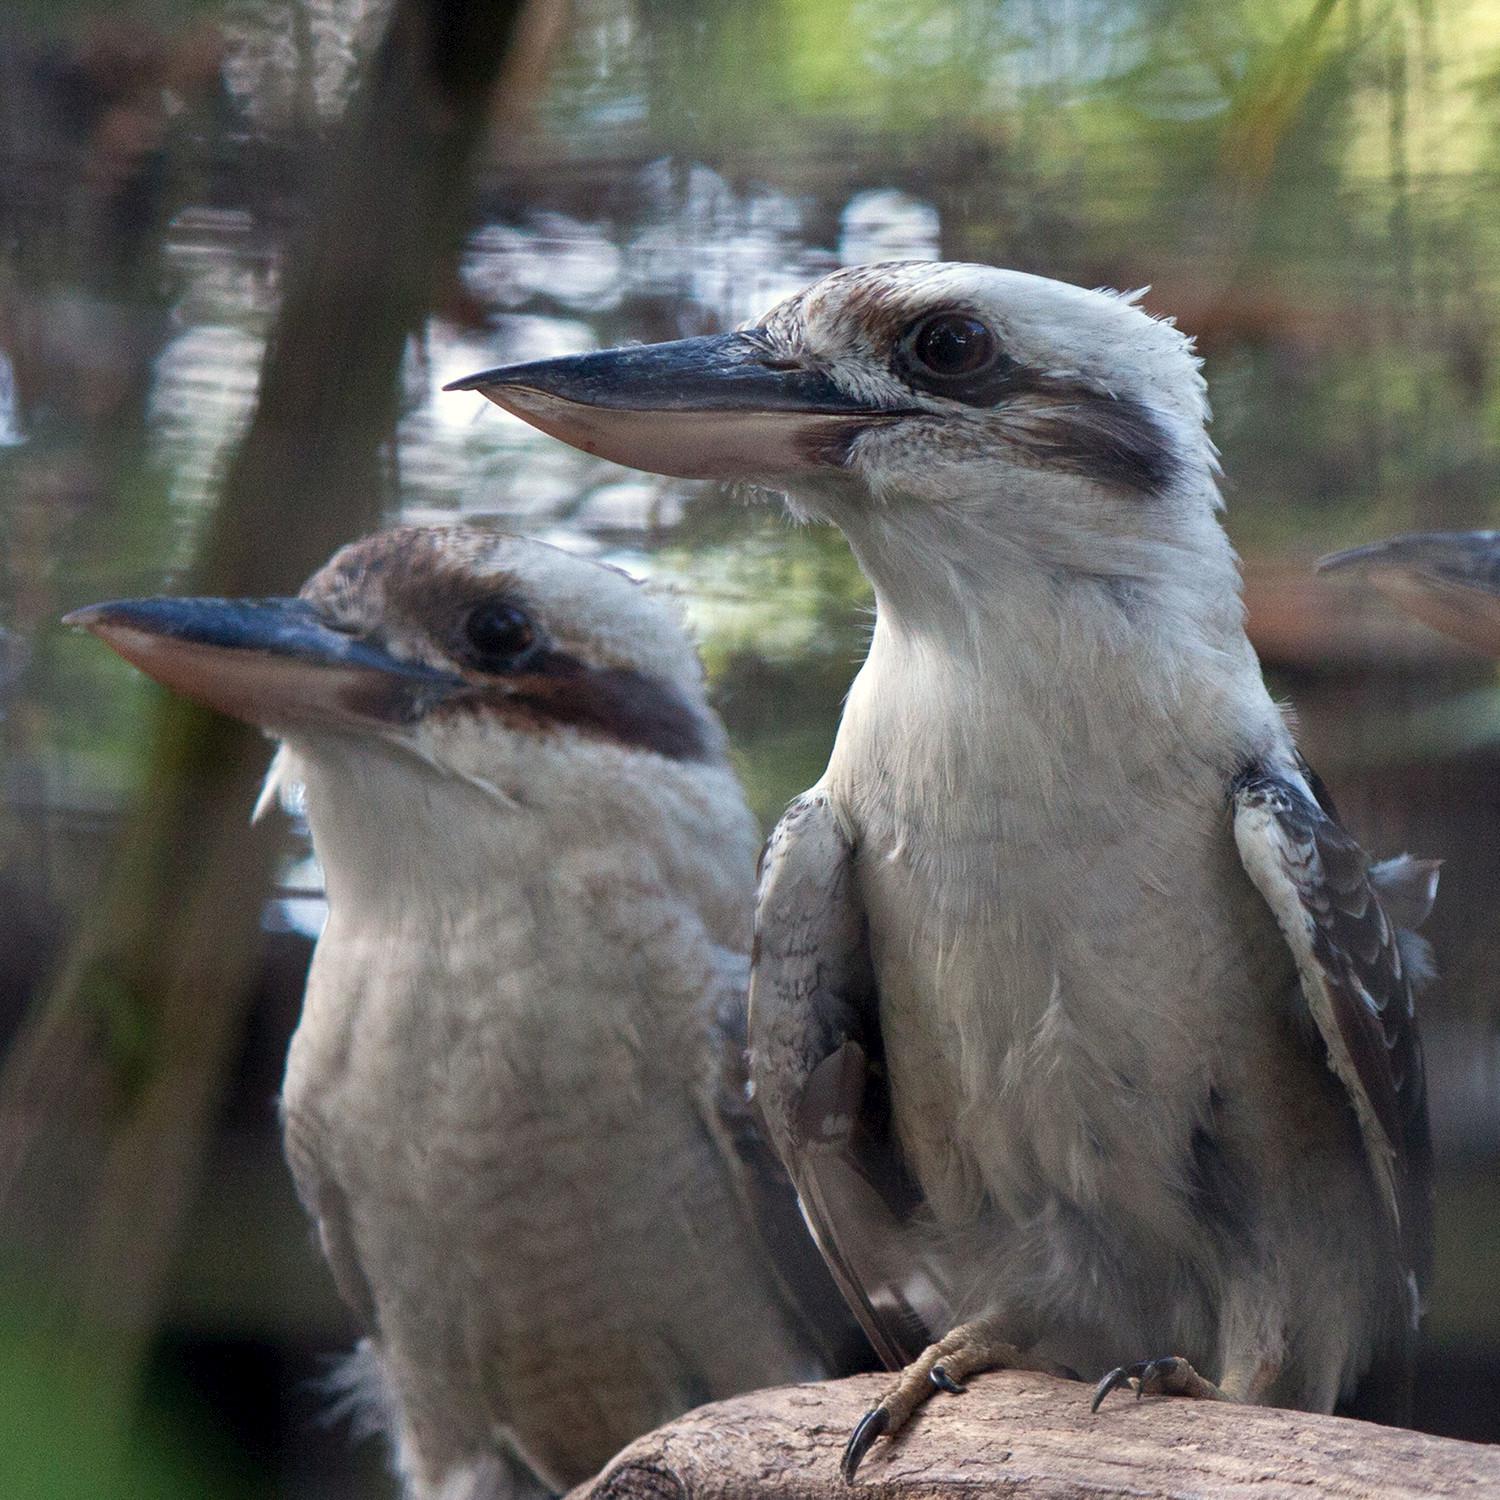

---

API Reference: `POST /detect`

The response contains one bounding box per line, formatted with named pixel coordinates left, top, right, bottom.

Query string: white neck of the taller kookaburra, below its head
left=830, top=498, right=1284, bottom=837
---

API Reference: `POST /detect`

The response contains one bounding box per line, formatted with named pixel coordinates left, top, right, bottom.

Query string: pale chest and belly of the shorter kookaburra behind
left=284, top=738, right=819, bottom=1488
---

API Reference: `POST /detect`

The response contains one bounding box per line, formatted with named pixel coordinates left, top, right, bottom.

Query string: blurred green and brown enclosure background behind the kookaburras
left=0, top=0, right=1500, bottom=1500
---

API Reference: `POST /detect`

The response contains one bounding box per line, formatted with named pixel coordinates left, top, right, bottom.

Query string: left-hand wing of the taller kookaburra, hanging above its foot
left=750, top=791, right=948, bottom=1370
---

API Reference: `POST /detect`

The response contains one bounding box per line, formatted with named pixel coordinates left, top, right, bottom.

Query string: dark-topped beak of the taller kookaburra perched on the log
left=444, top=333, right=902, bottom=483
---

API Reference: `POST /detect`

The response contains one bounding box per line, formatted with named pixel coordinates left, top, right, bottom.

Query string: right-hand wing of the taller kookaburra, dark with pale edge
left=1232, top=765, right=1437, bottom=1326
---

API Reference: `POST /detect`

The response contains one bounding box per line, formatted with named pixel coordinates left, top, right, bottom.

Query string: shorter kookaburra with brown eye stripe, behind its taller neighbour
left=68, top=525, right=869, bottom=1500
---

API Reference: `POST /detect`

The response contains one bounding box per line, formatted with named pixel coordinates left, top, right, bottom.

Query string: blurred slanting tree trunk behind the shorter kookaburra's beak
left=0, top=0, right=534, bottom=1427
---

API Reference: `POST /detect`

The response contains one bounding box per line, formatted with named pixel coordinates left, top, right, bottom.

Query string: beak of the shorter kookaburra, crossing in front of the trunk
left=63, top=599, right=465, bottom=731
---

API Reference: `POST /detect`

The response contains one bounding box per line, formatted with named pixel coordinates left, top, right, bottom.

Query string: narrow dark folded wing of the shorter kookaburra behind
left=710, top=956, right=876, bottom=1376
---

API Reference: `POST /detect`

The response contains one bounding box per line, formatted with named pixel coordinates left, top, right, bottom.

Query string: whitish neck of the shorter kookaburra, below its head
left=277, top=740, right=756, bottom=948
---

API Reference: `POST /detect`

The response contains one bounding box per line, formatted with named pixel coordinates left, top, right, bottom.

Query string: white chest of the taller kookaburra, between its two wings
left=830, top=609, right=1293, bottom=1242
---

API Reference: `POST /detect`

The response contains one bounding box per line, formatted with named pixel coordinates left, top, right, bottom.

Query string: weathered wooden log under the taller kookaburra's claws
left=569, top=1374, right=1500, bottom=1500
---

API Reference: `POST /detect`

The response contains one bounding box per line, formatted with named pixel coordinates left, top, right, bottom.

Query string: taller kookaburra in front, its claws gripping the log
left=452, top=261, right=1437, bottom=1482
